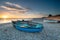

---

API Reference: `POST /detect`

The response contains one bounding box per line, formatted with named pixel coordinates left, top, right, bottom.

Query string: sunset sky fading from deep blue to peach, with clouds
left=0, top=0, right=60, bottom=18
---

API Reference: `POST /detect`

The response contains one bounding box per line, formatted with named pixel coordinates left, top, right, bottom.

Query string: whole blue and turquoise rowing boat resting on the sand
left=12, top=20, right=43, bottom=32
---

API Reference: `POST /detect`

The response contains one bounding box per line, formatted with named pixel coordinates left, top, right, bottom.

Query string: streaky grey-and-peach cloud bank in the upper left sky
left=0, top=2, right=28, bottom=13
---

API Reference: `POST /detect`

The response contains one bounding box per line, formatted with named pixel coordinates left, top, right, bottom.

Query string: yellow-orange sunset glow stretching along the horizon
left=0, top=11, right=43, bottom=19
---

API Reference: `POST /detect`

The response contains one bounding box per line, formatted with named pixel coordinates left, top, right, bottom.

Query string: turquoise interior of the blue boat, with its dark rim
left=12, top=20, right=42, bottom=28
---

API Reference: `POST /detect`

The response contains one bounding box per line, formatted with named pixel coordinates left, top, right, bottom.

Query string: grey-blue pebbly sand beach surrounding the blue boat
left=0, top=23, right=60, bottom=40
